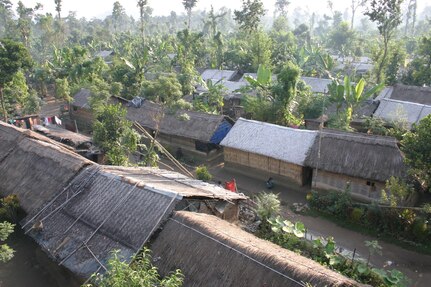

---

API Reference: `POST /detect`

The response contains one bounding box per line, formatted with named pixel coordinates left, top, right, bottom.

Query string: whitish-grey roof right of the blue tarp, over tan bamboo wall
left=221, top=118, right=317, bottom=166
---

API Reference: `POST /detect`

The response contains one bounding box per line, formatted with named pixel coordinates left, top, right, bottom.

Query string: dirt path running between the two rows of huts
left=210, top=163, right=431, bottom=287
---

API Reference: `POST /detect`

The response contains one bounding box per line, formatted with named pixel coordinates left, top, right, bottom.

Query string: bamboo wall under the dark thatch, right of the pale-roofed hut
left=313, top=170, right=385, bottom=200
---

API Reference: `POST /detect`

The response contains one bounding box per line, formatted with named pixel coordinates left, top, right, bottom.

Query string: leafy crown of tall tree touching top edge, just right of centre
left=234, top=0, right=265, bottom=32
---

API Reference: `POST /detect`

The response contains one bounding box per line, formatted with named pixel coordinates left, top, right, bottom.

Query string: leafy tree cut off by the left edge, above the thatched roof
left=0, top=39, right=32, bottom=121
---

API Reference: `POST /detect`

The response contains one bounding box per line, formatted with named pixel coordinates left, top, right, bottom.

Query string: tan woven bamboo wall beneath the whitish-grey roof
left=224, top=147, right=305, bottom=185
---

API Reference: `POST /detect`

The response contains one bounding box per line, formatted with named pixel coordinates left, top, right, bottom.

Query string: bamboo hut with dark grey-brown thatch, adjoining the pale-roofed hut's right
left=306, top=130, right=406, bottom=200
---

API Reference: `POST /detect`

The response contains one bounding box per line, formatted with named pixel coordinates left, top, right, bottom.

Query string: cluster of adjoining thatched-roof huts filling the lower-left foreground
left=0, top=122, right=366, bottom=286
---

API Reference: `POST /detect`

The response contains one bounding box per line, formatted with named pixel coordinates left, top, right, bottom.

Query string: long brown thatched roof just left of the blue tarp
left=127, top=101, right=233, bottom=144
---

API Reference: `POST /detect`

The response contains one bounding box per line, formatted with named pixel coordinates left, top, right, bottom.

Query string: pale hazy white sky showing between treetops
left=8, top=0, right=431, bottom=18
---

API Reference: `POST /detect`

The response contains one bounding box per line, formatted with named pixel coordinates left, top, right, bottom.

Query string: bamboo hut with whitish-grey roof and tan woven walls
left=221, top=118, right=317, bottom=185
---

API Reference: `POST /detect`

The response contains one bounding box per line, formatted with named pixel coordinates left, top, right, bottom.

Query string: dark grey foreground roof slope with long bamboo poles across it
left=24, top=166, right=181, bottom=278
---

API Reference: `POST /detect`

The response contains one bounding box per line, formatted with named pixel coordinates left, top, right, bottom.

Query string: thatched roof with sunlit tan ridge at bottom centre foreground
left=151, top=211, right=361, bottom=287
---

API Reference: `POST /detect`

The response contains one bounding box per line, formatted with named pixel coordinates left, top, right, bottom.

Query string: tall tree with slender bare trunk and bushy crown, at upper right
left=365, top=0, right=404, bottom=83
